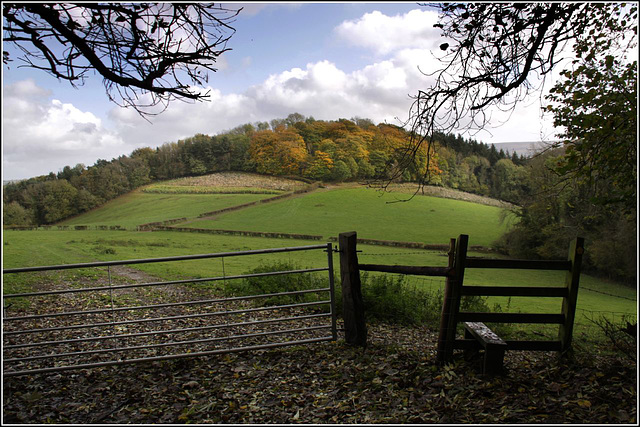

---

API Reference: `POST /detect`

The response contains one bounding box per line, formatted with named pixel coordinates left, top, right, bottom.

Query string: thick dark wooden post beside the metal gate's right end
left=338, top=231, right=367, bottom=347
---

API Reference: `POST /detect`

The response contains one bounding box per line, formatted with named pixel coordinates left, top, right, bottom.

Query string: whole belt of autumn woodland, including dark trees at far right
left=3, top=113, right=636, bottom=280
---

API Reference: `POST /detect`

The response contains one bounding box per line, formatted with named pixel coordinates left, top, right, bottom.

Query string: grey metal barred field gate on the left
left=3, top=243, right=337, bottom=376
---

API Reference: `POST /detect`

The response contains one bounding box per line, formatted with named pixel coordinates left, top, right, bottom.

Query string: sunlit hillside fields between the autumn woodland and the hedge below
left=60, top=172, right=507, bottom=246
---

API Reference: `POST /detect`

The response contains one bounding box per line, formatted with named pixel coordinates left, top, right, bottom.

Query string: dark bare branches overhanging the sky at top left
left=2, top=2, right=241, bottom=114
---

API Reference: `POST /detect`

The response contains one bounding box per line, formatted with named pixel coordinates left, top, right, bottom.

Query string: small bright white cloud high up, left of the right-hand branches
left=335, top=9, right=440, bottom=55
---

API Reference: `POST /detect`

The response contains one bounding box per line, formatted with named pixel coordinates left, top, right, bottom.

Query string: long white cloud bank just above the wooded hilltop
left=100, top=55, right=415, bottom=154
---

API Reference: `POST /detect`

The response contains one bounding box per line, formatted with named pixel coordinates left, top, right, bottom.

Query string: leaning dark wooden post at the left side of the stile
left=443, top=234, right=469, bottom=362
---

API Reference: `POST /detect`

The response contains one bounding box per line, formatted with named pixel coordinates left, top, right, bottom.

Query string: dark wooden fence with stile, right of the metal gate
left=339, top=232, right=584, bottom=372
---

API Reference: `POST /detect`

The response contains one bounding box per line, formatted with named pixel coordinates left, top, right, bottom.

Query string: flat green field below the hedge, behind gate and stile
left=3, top=230, right=637, bottom=332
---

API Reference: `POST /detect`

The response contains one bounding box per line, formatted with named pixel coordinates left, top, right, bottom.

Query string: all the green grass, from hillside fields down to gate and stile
left=3, top=181, right=637, bottom=342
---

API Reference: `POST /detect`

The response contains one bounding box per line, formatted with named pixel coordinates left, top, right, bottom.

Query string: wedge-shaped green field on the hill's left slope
left=60, top=190, right=273, bottom=228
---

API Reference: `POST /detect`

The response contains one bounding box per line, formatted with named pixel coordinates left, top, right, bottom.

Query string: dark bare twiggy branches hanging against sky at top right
left=396, top=2, right=638, bottom=201
